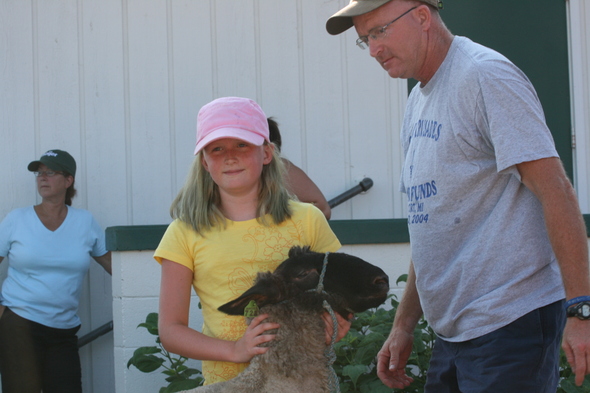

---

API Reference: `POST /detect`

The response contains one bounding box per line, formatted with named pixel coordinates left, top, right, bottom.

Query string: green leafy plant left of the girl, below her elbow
left=127, top=312, right=204, bottom=393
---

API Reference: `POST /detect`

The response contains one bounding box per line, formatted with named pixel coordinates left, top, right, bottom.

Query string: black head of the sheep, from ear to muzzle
left=219, top=247, right=389, bottom=315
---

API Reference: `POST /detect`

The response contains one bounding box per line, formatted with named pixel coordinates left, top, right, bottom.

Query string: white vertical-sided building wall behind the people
left=0, top=0, right=590, bottom=393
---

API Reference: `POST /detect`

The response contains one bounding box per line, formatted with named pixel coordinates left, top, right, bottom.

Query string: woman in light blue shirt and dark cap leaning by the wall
left=0, top=149, right=111, bottom=393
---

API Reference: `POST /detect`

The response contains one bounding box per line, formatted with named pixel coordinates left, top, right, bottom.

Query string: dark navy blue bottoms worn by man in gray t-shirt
left=424, top=301, right=566, bottom=393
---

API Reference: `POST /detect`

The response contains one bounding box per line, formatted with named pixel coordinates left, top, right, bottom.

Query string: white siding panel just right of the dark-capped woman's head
left=79, top=0, right=130, bottom=228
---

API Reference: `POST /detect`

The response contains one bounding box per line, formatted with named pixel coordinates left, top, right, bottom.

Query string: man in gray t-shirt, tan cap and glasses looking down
left=326, top=0, right=590, bottom=393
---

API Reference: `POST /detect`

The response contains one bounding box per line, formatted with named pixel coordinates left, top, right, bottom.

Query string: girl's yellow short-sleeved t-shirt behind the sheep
left=154, top=201, right=341, bottom=384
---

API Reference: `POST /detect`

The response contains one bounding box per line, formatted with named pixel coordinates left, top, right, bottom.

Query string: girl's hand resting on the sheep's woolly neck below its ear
left=232, top=314, right=280, bottom=363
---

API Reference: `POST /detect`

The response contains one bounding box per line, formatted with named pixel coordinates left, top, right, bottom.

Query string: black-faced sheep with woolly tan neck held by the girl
left=184, top=247, right=389, bottom=393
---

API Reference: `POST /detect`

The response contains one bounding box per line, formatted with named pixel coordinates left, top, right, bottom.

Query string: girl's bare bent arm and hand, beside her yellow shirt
left=158, top=259, right=279, bottom=363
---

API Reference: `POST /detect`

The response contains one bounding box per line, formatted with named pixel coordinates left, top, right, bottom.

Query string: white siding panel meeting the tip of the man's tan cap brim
left=300, top=1, right=352, bottom=219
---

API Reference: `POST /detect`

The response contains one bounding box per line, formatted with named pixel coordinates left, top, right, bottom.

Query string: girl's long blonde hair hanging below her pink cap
left=170, top=142, right=293, bottom=236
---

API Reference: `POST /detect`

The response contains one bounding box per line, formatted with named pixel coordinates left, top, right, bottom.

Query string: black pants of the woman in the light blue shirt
left=0, top=307, right=82, bottom=393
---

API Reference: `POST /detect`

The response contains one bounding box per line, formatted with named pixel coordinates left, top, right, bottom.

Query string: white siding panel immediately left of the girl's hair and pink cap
left=127, top=0, right=171, bottom=225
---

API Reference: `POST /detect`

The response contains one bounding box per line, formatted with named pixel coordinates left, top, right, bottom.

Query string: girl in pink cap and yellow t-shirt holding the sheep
left=154, top=97, right=350, bottom=384
